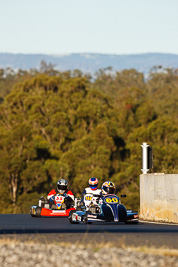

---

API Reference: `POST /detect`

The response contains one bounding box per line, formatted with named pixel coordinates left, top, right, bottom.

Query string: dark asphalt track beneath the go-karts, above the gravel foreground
left=0, top=214, right=178, bottom=249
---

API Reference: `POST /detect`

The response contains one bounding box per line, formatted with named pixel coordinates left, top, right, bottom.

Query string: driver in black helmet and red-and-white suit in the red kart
left=47, top=179, right=74, bottom=209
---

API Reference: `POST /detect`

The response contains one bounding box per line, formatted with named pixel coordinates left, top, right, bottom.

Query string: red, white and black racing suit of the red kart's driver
left=47, top=189, right=74, bottom=209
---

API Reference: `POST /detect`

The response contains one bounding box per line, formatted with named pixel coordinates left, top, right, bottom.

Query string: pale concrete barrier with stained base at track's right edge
left=140, top=173, right=178, bottom=223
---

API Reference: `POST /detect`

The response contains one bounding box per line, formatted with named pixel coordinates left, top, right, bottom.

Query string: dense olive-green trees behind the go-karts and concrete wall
left=0, top=66, right=178, bottom=213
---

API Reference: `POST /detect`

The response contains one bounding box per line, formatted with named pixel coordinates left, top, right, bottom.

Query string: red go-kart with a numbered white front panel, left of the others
left=30, top=194, right=75, bottom=217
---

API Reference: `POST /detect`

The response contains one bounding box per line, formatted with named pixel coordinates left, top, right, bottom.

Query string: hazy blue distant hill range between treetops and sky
left=0, top=53, right=178, bottom=74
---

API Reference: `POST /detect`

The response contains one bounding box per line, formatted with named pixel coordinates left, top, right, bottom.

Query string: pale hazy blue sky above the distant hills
left=0, top=0, right=178, bottom=54
